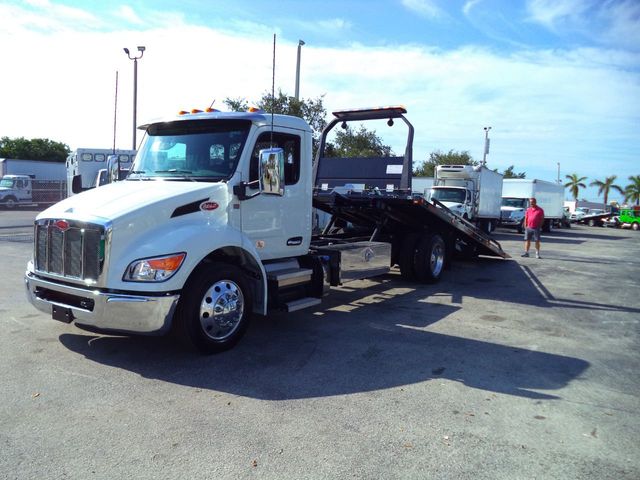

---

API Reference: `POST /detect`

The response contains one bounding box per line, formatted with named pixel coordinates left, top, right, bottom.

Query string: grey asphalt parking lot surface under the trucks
left=0, top=212, right=640, bottom=479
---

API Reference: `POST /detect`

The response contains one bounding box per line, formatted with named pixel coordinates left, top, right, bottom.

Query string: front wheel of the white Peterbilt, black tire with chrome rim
left=174, top=263, right=253, bottom=354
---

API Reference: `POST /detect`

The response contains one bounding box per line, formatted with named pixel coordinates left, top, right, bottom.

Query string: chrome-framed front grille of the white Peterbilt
left=34, top=220, right=105, bottom=280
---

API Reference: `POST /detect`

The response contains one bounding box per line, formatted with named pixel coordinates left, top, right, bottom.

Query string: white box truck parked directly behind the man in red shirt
left=500, top=178, right=569, bottom=232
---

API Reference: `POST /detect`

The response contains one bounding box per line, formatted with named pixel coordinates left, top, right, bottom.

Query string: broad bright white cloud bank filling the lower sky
left=0, top=0, right=640, bottom=197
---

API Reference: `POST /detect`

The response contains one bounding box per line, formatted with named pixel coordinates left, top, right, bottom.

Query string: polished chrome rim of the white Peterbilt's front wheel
left=200, top=280, right=244, bottom=341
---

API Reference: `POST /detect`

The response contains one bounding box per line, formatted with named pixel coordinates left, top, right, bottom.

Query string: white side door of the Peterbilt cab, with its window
left=240, top=127, right=311, bottom=260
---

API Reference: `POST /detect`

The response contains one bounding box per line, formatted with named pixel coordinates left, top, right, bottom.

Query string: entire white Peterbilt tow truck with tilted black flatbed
left=25, top=107, right=508, bottom=353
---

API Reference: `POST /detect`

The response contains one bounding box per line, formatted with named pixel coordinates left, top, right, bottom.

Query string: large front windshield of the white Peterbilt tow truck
left=128, top=120, right=251, bottom=181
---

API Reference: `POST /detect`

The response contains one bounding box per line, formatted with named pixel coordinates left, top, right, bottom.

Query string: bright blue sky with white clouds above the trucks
left=0, top=0, right=640, bottom=200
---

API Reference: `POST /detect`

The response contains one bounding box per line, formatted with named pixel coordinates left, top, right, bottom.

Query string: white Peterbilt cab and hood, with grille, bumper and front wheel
left=25, top=112, right=312, bottom=351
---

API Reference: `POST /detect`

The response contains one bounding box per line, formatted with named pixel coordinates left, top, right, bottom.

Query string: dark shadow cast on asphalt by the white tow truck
left=60, top=262, right=589, bottom=400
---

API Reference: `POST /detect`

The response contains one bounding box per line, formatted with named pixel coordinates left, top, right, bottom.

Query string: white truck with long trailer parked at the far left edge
left=0, top=158, right=66, bottom=208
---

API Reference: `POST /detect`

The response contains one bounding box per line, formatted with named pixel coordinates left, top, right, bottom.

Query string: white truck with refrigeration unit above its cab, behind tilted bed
left=430, top=165, right=502, bottom=233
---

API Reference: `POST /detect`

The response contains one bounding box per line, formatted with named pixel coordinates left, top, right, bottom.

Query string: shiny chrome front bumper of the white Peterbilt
left=24, top=271, right=180, bottom=335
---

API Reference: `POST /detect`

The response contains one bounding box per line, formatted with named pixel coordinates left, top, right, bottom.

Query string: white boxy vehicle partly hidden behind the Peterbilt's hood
left=66, top=148, right=136, bottom=196
